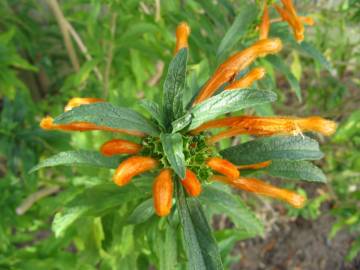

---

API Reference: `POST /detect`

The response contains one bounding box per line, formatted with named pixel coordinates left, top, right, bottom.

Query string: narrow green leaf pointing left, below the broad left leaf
left=29, top=150, right=122, bottom=173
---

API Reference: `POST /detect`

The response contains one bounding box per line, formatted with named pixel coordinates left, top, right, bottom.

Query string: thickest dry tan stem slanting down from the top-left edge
left=47, top=0, right=80, bottom=71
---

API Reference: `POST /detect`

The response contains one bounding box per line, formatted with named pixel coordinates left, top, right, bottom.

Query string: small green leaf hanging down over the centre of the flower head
left=160, top=133, right=185, bottom=179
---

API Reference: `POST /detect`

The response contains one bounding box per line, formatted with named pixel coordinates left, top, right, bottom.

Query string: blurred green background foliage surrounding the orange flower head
left=0, top=0, right=360, bottom=269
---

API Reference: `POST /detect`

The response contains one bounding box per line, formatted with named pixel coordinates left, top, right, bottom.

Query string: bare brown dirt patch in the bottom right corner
left=231, top=215, right=360, bottom=270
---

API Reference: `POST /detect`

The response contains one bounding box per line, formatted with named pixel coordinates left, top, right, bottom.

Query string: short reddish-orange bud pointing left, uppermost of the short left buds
left=100, top=139, right=141, bottom=156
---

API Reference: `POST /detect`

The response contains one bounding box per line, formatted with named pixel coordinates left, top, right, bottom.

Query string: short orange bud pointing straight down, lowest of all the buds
left=153, top=169, right=174, bottom=217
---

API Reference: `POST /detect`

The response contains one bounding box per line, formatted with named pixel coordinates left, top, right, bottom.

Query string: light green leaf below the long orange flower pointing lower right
left=199, top=185, right=264, bottom=236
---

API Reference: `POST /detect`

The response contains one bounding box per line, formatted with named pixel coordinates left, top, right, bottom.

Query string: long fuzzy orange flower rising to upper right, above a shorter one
left=193, top=38, right=282, bottom=105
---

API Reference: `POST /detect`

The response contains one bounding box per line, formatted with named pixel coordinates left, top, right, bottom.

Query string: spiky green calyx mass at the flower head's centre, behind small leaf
left=140, top=134, right=215, bottom=181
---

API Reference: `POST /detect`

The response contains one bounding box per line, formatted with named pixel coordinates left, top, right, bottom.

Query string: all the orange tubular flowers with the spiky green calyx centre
left=40, top=0, right=336, bottom=216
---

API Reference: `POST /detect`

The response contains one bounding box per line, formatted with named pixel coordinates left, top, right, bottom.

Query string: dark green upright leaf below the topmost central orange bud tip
left=163, top=48, right=188, bottom=125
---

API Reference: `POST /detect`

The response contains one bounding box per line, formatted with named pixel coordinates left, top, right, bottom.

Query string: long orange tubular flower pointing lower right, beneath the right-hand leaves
left=213, top=176, right=306, bottom=208
